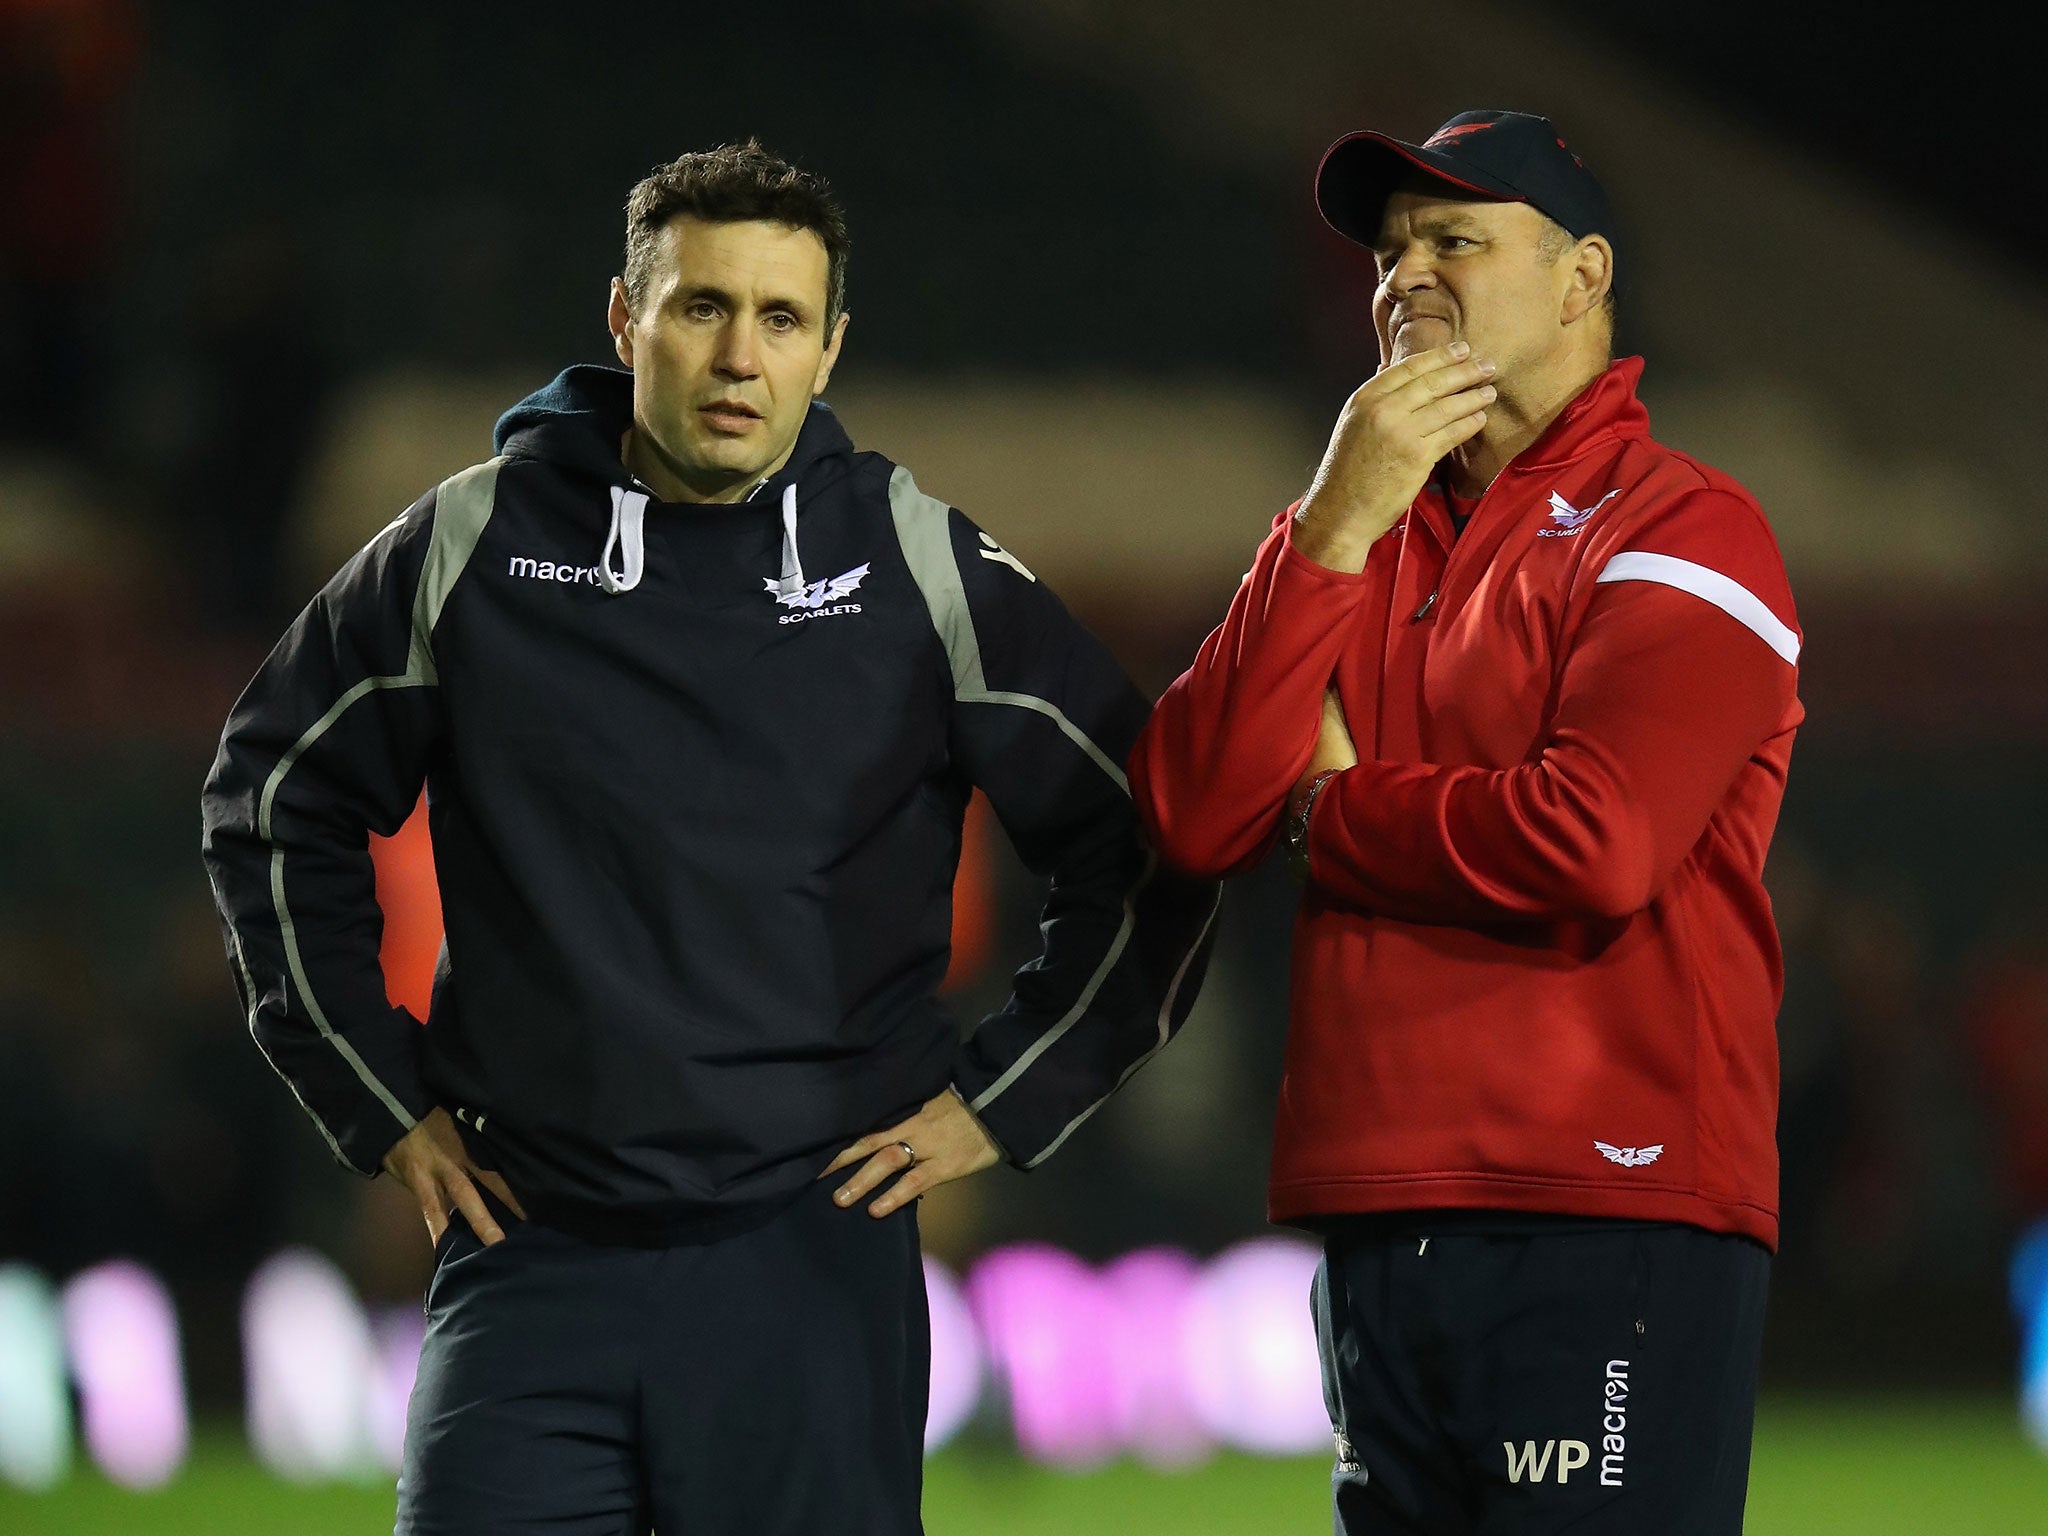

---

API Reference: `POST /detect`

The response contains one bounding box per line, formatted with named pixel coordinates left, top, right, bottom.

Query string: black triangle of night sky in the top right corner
left=1526, top=0, right=2048, bottom=274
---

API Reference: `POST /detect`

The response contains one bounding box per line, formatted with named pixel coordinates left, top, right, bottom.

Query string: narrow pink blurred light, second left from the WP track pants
left=1102, top=1247, right=1217, bottom=1466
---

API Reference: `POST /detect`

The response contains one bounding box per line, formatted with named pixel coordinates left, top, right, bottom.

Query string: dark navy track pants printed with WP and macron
left=1313, top=1212, right=1769, bottom=1536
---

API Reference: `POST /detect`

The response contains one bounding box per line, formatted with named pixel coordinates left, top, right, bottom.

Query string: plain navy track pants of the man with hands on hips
left=397, top=1180, right=930, bottom=1536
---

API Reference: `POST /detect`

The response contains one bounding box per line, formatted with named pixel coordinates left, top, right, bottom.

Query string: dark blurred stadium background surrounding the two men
left=0, top=0, right=2048, bottom=1532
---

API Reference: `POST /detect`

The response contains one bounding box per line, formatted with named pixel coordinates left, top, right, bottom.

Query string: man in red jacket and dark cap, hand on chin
left=1130, top=113, right=1800, bottom=1536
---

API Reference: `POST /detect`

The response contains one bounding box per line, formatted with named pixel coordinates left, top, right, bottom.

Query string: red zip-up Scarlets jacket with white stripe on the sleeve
left=1130, top=358, right=1802, bottom=1247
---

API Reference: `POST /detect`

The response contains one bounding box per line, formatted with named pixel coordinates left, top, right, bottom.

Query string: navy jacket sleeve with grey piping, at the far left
left=201, top=483, right=456, bottom=1176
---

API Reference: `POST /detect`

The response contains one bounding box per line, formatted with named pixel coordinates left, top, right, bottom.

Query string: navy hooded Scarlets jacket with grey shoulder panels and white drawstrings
left=203, top=367, right=1217, bottom=1243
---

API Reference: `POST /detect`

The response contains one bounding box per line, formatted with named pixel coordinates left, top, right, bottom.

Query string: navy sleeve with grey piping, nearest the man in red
left=891, top=469, right=1221, bottom=1167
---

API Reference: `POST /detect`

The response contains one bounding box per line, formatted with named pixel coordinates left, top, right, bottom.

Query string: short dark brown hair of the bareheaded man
left=625, top=139, right=852, bottom=332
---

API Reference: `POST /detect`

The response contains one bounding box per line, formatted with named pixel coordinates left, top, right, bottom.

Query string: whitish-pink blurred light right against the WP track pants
left=1182, top=1237, right=1329, bottom=1456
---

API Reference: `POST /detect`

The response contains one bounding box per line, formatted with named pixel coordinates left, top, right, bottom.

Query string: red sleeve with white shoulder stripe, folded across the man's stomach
left=1309, top=492, right=1800, bottom=922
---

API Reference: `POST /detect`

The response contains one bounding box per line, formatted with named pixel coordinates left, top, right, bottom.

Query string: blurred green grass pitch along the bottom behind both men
left=0, top=1399, right=2048, bottom=1536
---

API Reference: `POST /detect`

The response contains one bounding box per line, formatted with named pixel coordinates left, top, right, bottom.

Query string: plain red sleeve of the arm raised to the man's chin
left=1130, top=508, right=1366, bottom=879
